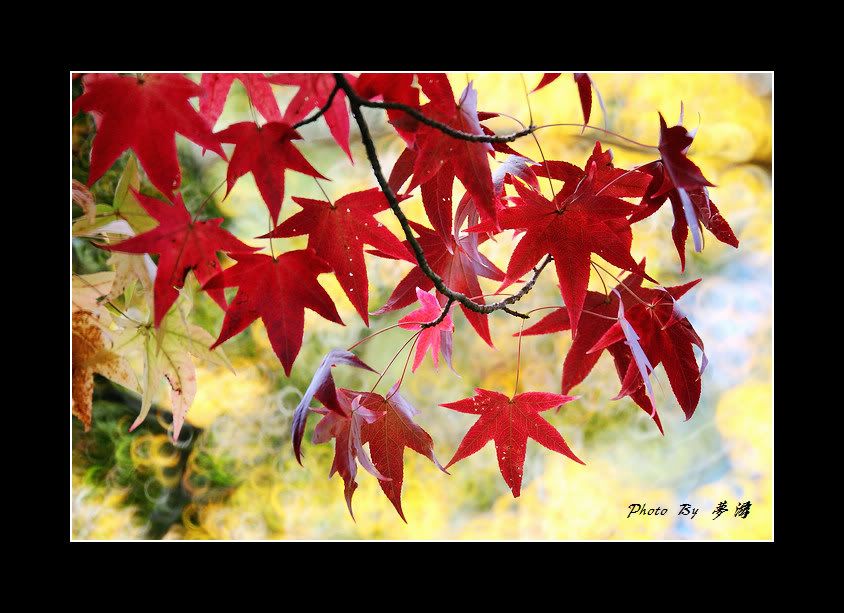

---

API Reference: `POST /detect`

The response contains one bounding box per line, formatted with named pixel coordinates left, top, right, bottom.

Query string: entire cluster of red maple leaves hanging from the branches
left=73, top=73, right=738, bottom=519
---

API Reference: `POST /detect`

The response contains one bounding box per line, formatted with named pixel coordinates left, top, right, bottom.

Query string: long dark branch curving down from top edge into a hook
left=334, top=74, right=553, bottom=325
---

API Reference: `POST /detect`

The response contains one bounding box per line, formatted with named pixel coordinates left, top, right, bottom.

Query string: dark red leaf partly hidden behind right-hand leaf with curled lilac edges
left=513, top=261, right=662, bottom=432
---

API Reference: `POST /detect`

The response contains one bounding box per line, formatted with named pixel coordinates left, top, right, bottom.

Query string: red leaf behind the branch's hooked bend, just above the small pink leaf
left=372, top=221, right=504, bottom=347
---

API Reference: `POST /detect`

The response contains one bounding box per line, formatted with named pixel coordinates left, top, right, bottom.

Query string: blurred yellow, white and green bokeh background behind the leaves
left=72, top=73, right=773, bottom=539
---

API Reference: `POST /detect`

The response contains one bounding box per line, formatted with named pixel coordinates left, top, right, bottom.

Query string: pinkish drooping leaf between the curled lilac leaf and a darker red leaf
left=311, top=389, right=389, bottom=519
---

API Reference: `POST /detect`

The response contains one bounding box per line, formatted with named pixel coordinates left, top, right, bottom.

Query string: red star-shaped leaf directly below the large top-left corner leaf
left=101, top=188, right=258, bottom=327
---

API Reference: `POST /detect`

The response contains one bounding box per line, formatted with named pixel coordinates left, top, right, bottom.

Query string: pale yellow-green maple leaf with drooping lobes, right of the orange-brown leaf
left=114, top=298, right=234, bottom=441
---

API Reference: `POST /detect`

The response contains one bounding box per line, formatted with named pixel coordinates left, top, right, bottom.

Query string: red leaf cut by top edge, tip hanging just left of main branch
left=268, top=73, right=357, bottom=160
